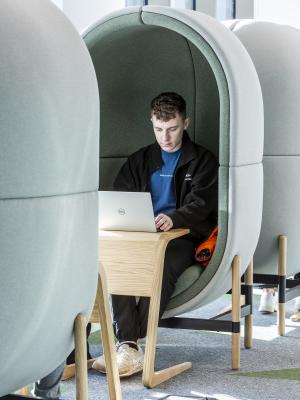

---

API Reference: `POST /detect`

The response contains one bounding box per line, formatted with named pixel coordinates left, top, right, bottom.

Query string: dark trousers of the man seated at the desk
left=111, top=238, right=196, bottom=342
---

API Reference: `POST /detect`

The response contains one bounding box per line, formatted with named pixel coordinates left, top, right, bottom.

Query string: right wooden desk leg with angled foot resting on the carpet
left=143, top=241, right=192, bottom=388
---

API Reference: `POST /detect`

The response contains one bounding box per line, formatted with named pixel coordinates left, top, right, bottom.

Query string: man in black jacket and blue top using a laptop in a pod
left=93, top=93, right=218, bottom=377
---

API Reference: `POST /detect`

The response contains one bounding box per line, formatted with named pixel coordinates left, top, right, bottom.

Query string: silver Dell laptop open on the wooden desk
left=98, top=191, right=156, bottom=232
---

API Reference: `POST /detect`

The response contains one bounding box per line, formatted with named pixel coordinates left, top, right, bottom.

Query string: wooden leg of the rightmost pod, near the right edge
left=277, top=235, right=287, bottom=336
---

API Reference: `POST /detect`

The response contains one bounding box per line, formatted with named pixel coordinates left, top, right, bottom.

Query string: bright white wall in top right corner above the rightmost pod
left=254, top=0, right=300, bottom=29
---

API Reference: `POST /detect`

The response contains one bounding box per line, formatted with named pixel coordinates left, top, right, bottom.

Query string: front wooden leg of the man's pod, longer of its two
left=231, top=256, right=241, bottom=369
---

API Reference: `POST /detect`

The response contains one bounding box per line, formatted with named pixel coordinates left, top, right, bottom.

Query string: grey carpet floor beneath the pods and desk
left=62, top=296, right=300, bottom=400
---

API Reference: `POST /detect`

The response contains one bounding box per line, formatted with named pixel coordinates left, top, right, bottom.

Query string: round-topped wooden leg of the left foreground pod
left=74, top=314, right=88, bottom=400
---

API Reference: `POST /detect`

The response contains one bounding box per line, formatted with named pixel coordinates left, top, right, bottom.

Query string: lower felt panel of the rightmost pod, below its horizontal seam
left=254, top=155, right=300, bottom=276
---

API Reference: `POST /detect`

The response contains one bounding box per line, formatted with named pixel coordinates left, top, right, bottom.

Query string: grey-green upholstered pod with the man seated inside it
left=83, top=6, right=263, bottom=316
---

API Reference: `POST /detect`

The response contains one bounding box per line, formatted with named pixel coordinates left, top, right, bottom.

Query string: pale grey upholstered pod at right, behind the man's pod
left=228, top=20, right=300, bottom=275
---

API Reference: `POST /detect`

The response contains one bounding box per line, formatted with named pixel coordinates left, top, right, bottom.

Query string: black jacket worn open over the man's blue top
left=114, top=132, right=218, bottom=242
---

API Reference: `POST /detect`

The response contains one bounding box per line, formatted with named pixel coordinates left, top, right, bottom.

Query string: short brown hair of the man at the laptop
left=151, top=92, right=186, bottom=121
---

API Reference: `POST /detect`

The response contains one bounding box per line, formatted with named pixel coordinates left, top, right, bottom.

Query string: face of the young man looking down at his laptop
left=151, top=113, right=189, bottom=153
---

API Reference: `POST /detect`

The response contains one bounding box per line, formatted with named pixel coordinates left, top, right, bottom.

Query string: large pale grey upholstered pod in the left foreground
left=0, top=0, right=99, bottom=396
